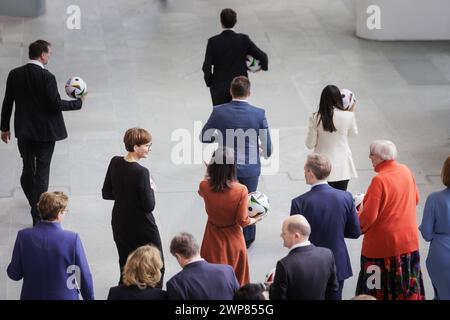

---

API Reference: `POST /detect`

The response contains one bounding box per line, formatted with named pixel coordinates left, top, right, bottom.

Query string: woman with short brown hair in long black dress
left=102, top=128, right=164, bottom=287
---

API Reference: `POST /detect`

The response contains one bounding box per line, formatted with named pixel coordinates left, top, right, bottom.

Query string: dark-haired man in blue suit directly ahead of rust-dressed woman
left=200, top=76, right=272, bottom=248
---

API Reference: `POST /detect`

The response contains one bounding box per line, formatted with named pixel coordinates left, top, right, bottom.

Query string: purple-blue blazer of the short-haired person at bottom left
left=7, top=222, right=94, bottom=300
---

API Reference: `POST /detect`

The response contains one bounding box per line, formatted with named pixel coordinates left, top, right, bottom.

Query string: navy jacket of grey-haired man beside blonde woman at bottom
left=166, top=260, right=239, bottom=300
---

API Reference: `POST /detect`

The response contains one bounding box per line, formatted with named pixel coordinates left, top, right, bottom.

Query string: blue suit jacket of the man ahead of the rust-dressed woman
left=200, top=101, right=272, bottom=178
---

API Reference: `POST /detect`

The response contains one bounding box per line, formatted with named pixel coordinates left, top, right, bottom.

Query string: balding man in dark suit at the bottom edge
left=269, top=215, right=338, bottom=300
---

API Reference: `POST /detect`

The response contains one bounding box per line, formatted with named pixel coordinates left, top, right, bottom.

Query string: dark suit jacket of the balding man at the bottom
left=269, top=244, right=339, bottom=300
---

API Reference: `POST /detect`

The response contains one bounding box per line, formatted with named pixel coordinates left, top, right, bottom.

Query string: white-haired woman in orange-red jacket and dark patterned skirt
left=356, top=140, right=425, bottom=300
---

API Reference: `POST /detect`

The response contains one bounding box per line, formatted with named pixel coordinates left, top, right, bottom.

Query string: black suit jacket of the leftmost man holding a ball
left=0, top=63, right=82, bottom=142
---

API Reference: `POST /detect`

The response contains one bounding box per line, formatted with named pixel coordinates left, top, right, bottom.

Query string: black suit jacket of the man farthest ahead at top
left=202, top=30, right=269, bottom=89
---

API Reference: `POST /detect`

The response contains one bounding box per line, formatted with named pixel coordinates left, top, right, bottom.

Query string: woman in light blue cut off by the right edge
left=419, top=156, right=450, bottom=300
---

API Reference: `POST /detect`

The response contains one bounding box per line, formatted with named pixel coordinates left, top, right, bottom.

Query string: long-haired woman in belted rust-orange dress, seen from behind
left=198, top=148, right=259, bottom=286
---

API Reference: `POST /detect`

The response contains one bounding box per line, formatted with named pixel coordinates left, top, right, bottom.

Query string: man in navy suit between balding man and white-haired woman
left=291, top=153, right=361, bottom=300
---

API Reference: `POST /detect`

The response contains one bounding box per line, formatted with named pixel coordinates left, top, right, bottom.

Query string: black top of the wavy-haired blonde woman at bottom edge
left=107, top=285, right=167, bottom=300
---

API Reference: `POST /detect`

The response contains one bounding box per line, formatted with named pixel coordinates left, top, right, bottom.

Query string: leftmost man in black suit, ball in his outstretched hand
left=0, top=40, right=85, bottom=225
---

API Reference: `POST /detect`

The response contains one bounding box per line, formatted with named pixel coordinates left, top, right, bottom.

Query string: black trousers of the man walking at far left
left=17, top=139, right=55, bottom=225
